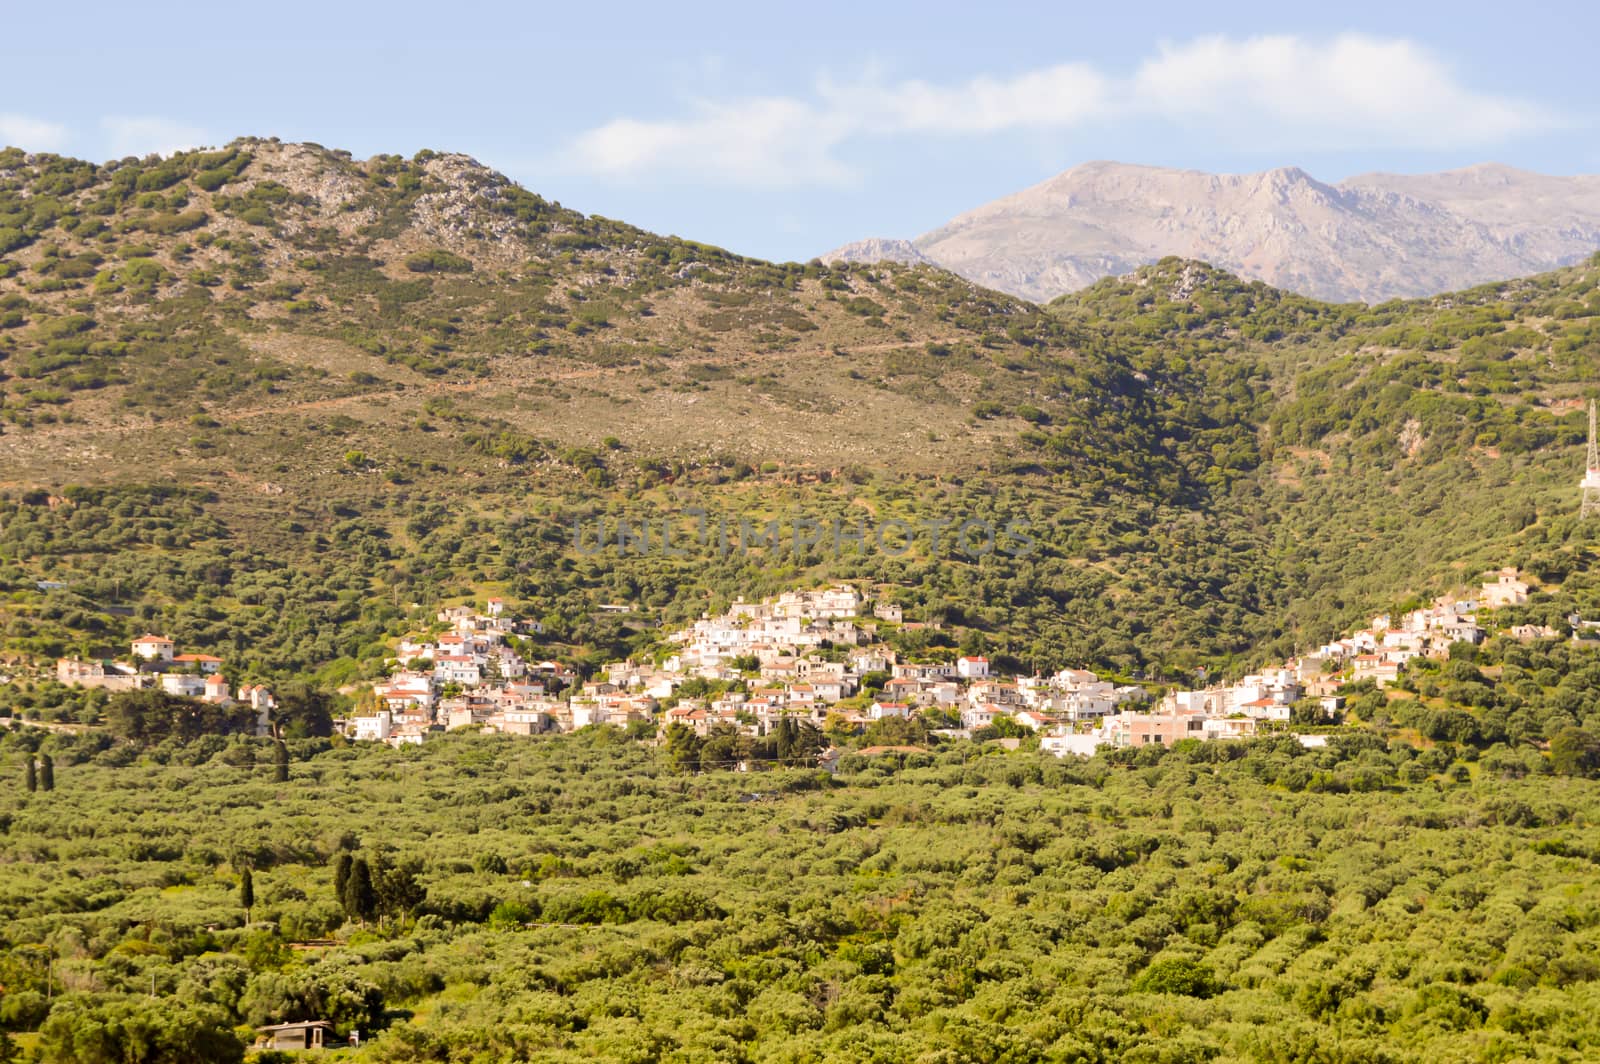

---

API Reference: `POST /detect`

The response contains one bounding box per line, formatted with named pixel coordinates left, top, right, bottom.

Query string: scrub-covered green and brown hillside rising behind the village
left=0, top=139, right=1600, bottom=683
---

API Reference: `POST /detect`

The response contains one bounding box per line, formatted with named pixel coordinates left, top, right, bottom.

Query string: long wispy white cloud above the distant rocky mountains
left=565, top=34, right=1557, bottom=186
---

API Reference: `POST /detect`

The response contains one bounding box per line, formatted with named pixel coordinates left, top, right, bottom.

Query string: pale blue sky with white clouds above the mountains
left=0, top=0, right=1600, bottom=259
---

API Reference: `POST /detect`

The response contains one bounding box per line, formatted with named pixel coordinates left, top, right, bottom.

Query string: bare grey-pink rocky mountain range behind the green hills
left=822, top=162, right=1600, bottom=302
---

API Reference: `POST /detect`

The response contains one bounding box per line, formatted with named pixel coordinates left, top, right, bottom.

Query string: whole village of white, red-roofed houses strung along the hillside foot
left=37, top=570, right=1557, bottom=763
